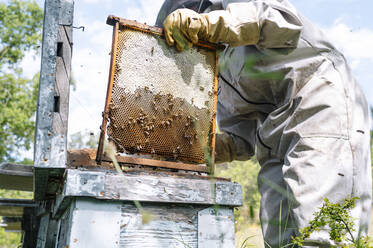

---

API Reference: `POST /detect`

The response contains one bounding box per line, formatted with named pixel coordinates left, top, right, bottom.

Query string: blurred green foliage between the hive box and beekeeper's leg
left=216, top=160, right=260, bottom=228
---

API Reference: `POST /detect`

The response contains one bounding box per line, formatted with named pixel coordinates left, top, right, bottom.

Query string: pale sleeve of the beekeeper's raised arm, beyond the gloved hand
left=202, top=0, right=302, bottom=48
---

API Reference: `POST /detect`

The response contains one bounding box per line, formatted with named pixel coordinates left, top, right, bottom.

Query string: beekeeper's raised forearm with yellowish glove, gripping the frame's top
left=164, top=0, right=302, bottom=51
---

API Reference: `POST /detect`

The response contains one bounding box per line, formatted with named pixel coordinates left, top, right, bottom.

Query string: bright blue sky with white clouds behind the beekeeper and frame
left=22, top=0, right=373, bottom=141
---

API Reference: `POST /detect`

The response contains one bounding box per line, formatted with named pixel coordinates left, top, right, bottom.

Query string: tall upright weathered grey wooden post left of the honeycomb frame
left=34, top=0, right=74, bottom=200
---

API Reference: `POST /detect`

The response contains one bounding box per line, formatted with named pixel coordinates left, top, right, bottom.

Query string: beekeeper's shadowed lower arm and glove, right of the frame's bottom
left=215, top=103, right=256, bottom=163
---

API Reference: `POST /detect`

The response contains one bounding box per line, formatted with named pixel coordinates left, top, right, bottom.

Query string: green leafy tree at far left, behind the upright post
left=0, top=0, right=43, bottom=162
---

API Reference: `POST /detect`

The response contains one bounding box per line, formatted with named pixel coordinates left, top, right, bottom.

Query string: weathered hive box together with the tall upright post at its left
left=18, top=0, right=242, bottom=248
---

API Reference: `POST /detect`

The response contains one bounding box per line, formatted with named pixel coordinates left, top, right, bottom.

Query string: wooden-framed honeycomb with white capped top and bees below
left=97, top=17, right=217, bottom=170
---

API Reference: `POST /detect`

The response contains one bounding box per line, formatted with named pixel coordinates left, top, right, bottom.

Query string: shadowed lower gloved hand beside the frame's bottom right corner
left=215, top=133, right=235, bottom=164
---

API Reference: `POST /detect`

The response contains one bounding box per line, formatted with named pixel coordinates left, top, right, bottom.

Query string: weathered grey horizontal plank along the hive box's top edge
left=57, top=169, right=242, bottom=207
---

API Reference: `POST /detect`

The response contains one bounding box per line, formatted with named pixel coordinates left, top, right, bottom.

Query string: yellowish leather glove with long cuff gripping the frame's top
left=163, top=4, right=259, bottom=51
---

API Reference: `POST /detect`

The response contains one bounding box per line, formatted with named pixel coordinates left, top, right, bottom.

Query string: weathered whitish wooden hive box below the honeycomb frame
left=53, top=150, right=242, bottom=248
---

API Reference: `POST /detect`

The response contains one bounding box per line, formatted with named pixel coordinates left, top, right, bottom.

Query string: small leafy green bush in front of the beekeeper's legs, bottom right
left=292, top=197, right=372, bottom=248
